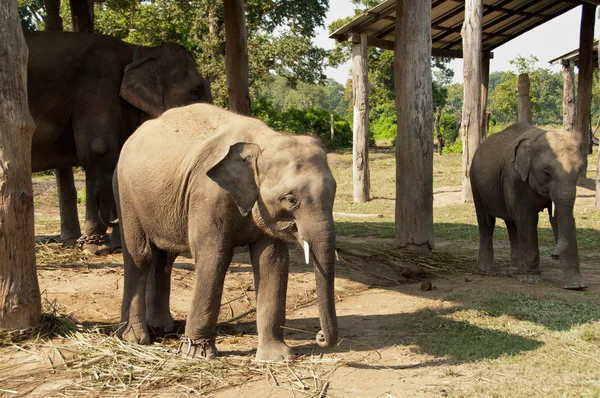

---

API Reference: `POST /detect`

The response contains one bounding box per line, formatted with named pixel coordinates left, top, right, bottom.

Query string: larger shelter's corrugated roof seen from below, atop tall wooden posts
left=329, top=0, right=600, bottom=57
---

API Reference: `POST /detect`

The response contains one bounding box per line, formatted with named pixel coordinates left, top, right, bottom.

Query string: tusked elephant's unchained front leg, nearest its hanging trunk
left=250, top=239, right=293, bottom=361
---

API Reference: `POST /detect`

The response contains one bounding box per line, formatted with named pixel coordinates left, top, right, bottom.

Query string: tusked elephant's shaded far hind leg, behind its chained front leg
left=146, top=249, right=177, bottom=332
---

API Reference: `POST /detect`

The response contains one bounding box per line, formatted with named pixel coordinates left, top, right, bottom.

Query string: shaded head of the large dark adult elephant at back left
left=119, top=43, right=212, bottom=118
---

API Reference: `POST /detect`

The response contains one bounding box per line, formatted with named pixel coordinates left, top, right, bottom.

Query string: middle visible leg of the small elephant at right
left=515, top=211, right=542, bottom=283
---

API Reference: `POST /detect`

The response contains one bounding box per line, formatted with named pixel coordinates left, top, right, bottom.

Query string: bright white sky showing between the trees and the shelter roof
left=313, top=0, right=600, bottom=84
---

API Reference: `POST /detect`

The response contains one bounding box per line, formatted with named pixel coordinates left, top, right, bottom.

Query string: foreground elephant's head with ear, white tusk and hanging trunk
left=208, top=135, right=338, bottom=347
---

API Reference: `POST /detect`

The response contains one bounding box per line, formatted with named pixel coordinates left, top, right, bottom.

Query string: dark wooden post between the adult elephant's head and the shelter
left=224, top=0, right=250, bottom=115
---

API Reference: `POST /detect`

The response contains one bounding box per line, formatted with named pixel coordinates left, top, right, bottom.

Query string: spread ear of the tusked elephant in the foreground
left=206, top=142, right=261, bottom=216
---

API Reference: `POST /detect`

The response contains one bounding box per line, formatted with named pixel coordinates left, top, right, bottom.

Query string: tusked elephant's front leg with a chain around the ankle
left=181, top=238, right=233, bottom=359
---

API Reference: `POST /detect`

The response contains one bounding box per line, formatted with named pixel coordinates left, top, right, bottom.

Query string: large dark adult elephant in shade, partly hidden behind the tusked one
left=25, top=32, right=212, bottom=254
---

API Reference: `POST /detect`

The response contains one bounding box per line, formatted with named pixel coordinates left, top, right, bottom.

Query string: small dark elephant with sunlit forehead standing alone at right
left=471, top=123, right=588, bottom=289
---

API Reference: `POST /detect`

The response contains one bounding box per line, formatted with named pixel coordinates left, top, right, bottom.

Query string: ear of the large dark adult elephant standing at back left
left=119, top=57, right=166, bottom=118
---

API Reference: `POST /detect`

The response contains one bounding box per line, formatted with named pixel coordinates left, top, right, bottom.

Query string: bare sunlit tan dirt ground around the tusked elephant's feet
left=0, top=169, right=600, bottom=397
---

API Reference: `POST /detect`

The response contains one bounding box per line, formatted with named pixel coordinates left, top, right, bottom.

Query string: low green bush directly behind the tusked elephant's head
left=252, top=97, right=352, bottom=149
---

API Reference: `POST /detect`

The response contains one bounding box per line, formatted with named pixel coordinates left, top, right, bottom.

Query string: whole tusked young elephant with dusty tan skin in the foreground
left=113, top=104, right=338, bottom=360
